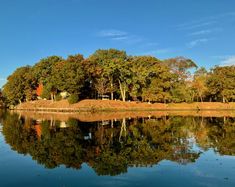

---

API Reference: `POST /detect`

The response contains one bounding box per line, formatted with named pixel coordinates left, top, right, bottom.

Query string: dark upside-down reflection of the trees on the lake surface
left=0, top=113, right=235, bottom=175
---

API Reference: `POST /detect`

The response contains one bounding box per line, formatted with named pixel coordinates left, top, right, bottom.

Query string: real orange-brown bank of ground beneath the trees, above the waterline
left=15, top=99, right=235, bottom=112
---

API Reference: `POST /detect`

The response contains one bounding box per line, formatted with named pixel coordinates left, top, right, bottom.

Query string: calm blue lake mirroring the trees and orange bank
left=0, top=111, right=235, bottom=187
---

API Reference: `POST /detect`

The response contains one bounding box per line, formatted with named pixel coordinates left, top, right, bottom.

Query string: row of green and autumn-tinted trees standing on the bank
left=1, top=49, right=235, bottom=105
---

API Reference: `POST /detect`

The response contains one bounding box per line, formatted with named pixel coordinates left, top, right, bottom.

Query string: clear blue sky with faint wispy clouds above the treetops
left=0, top=0, right=235, bottom=87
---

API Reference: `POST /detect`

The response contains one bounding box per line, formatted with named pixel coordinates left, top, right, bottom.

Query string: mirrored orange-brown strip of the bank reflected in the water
left=13, top=110, right=235, bottom=122
